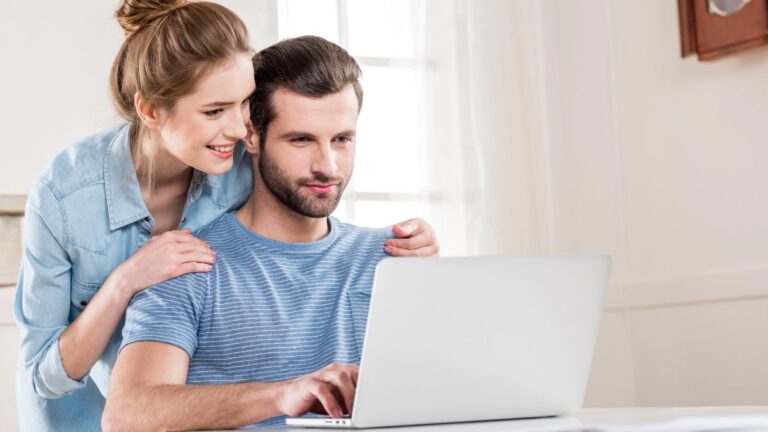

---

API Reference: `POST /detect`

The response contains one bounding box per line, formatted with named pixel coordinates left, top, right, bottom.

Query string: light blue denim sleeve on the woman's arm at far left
left=14, top=179, right=88, bottom=398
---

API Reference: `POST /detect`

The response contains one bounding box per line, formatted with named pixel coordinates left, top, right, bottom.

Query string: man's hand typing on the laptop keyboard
left=276, top=364, right=359, bottom=418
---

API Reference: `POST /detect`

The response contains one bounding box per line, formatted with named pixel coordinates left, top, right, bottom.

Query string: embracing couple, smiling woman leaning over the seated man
left=15, top=0, right=437, bottom=430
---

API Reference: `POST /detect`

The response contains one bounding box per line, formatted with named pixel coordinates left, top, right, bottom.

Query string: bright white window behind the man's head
left=278, top=0, right=429, bottom=226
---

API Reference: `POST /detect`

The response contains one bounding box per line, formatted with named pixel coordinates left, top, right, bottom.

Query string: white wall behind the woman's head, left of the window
left=0, top=0, right=277, bottom=195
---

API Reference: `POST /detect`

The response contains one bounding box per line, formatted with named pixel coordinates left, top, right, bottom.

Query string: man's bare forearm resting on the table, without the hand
left=102, top=382, right=284, bottom=431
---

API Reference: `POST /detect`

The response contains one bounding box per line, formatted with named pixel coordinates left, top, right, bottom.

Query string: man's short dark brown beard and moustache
left=259, top=152, right=347, bottom=218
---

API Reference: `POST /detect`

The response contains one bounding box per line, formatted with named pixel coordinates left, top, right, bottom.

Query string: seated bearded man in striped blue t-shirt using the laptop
left=102, top=37, right=424, bottom=430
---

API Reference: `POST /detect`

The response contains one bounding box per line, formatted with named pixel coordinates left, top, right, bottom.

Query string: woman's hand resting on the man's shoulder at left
left=110, top=229, right=216, bottom=296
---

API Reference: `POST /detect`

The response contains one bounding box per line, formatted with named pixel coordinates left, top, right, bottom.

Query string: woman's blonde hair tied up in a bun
left=110, top=0, right=252, bottom=191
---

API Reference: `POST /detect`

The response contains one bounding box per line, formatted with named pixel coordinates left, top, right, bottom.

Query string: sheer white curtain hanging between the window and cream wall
left=413, top=0, right=547, bottom=255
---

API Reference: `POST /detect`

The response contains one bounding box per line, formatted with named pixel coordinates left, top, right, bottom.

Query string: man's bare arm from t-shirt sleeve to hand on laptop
left=102, top=342, right=358, bottom=431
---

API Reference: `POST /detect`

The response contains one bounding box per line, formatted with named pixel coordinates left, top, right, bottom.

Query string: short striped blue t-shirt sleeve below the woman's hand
left=120, top=273, right=208, bottom=358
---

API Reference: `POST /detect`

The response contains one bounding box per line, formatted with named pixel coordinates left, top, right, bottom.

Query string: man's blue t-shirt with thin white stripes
left=122, top=213, right=392, bottom=423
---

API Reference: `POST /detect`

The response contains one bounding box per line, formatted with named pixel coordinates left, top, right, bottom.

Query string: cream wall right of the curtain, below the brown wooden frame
left=500, top=0, right=768, bottom=406
